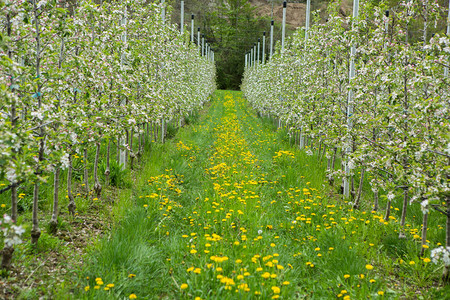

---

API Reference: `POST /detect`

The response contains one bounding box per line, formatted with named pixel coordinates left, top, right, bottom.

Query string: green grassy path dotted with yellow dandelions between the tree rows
left=77, top=91, right=446, bottom=299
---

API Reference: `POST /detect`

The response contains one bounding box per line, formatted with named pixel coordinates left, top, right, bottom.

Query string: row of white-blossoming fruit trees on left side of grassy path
left=0, top=0, right=215, bottom=267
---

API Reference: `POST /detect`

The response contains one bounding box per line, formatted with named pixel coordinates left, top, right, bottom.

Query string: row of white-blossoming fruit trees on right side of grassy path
left=242, top=1, right=450, bottom=280
